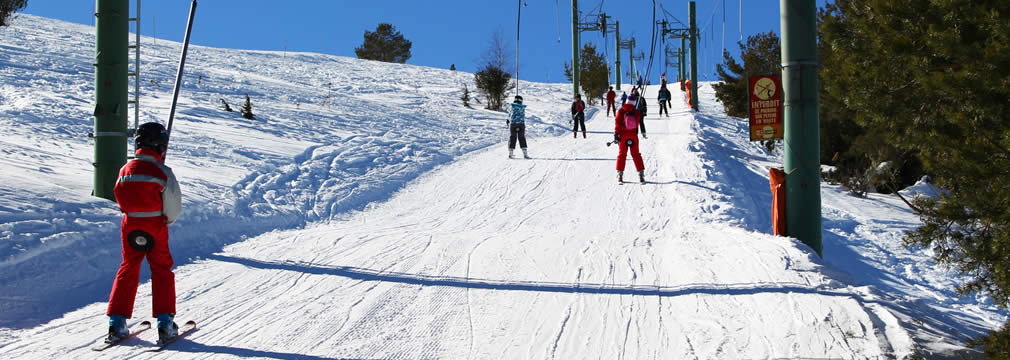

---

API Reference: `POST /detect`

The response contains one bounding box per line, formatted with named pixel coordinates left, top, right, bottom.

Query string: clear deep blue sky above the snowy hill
left=22, top=0, right=824, bottom=83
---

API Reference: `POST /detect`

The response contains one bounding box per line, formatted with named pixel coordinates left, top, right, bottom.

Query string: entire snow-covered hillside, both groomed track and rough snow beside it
left=0, top=15, right=1006, bottom=359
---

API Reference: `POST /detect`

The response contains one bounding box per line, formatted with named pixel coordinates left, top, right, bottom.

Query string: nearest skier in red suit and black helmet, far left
left=106, top=122, right=182, bottom=342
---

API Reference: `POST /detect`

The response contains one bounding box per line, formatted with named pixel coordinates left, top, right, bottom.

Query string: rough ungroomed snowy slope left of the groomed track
left=0, top=15, right=568, bottom=327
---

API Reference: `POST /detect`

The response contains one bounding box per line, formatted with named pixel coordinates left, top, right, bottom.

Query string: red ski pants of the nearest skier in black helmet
left=106, top=216, right=176, bottom=318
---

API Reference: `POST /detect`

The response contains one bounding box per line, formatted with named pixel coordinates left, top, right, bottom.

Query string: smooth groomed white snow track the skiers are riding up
left=0, top=88, right=910, bottom=359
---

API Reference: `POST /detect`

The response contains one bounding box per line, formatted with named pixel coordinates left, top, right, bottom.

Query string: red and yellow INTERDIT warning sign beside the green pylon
left=747, top=75, right=784, bottom=142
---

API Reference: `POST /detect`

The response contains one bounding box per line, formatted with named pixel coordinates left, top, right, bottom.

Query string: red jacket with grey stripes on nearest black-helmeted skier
left=113, top=149, right=182, bottom=224
